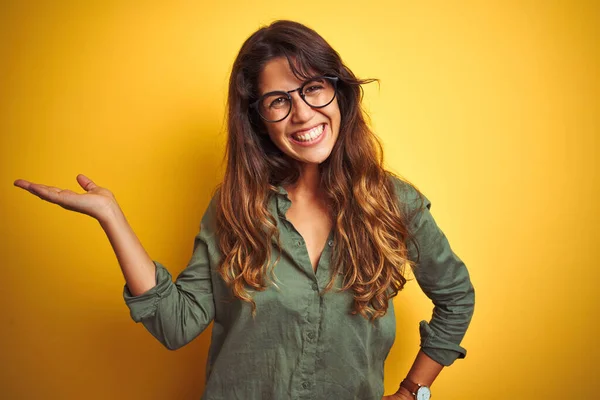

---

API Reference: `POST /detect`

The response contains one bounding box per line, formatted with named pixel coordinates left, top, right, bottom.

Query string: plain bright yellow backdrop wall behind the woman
left=0, top=0, right=600, bottom=400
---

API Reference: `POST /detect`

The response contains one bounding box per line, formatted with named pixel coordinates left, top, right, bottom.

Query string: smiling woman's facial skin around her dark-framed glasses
left=258, top=57, right=341, bottom=164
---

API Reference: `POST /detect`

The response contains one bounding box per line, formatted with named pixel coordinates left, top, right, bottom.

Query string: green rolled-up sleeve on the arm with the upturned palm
left=123, top=202, right=215, bottom=350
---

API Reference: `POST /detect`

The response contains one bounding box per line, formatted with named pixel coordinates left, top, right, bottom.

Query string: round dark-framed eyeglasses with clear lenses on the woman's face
left=250, top=76, right=338, bottom=122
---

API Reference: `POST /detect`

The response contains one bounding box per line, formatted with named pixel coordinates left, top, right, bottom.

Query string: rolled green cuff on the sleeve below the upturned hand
left=123, top=261, right=174, bottom=322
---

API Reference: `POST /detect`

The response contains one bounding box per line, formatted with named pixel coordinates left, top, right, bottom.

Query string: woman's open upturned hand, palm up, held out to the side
left=14, top=174, right=117, bottom=220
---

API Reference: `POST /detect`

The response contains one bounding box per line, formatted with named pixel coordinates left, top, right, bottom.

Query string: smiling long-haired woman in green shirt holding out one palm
left=15, top=21, right=474, bottom=400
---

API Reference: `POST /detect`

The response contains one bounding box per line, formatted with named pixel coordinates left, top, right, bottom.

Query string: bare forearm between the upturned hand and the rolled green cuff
left=98, top=204, right=156, bottom=296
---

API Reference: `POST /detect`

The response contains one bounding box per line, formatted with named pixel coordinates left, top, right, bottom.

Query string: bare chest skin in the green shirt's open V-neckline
left=286, top=202, right=332, bottom=271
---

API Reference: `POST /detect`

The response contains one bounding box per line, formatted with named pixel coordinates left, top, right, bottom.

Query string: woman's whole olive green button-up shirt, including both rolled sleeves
left=123, top=178, right=474, bottom=400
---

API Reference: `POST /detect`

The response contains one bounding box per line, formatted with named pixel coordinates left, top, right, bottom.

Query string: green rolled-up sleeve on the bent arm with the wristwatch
left=397, top=178, right=475, bottom=366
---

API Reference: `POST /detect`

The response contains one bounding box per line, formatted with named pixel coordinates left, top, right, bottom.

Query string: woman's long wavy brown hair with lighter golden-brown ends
left=217, top=21, right=422, bottom=321
